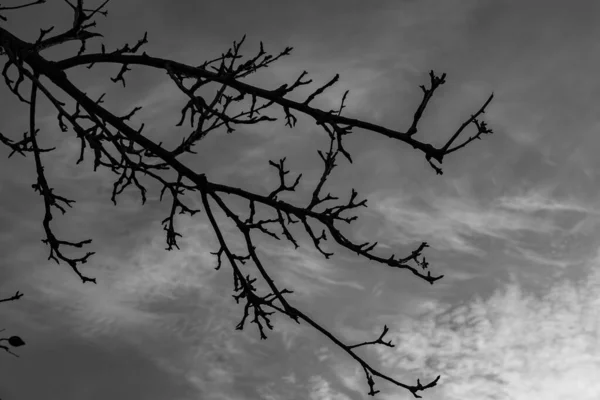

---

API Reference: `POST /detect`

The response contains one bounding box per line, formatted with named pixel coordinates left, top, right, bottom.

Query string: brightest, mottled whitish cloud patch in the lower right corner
left=374, top=266, right=600, bottom=400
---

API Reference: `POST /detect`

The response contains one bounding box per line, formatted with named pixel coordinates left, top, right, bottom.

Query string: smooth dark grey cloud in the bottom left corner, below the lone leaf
left=0, top=329, right=198, bottom=400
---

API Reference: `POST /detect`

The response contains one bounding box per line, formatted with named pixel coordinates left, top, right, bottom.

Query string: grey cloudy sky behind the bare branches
left=0, top=0, right=600, bottom=400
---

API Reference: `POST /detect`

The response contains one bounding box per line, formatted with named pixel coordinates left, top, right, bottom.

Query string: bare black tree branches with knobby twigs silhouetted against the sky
left=0, top=0, right=493, bottom=397
